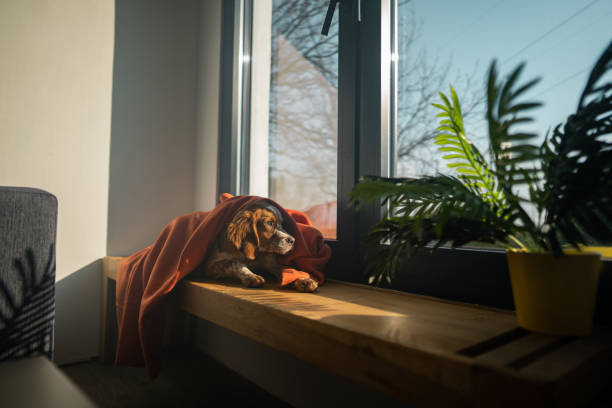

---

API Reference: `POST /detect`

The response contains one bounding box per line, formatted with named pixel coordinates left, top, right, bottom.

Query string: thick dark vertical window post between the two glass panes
left=328, top=0, right=393, bottom=283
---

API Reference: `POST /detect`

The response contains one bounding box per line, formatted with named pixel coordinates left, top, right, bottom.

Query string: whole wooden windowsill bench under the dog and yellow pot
left=104, top=257, right=612, bottom=406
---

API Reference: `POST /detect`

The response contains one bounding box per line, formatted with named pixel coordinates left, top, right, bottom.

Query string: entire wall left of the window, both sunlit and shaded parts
left=0, top=0, right=221, bottom=364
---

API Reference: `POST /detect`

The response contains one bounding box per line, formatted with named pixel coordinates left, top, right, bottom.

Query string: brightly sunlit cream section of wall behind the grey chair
left=0, top=0, right=114, bottom=281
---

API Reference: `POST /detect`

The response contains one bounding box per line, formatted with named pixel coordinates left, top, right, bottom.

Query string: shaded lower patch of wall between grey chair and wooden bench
left=55, top=259, right=102, bottom=364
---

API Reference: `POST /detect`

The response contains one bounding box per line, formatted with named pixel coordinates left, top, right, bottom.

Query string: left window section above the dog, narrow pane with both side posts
left=218, top=0, right=391, bottom=280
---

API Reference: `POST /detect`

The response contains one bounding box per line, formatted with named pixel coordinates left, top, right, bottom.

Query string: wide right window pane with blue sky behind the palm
left=395, top=0, right=612, bottom=245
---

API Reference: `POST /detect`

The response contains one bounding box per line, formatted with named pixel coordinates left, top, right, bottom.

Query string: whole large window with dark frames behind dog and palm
left=219, top=0, right=611, bottom=308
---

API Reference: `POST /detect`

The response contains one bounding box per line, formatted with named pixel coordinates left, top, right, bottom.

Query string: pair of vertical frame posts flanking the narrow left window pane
left=217, top=0, right=396, bottom=282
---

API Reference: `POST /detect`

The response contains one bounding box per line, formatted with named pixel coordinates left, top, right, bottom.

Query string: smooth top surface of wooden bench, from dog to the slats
left=183, top=281, right=516, bottom=354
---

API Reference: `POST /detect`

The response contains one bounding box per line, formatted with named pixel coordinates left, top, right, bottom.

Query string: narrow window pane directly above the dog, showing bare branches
left=268, top=0, right=338, bottom=238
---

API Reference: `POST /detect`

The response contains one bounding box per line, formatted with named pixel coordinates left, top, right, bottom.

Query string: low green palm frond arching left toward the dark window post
left=351, top=175, right=516, bottom=283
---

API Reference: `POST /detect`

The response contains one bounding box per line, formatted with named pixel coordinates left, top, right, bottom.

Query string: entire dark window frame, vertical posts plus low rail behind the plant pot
left=217, top=0, right=612, bottom=322
